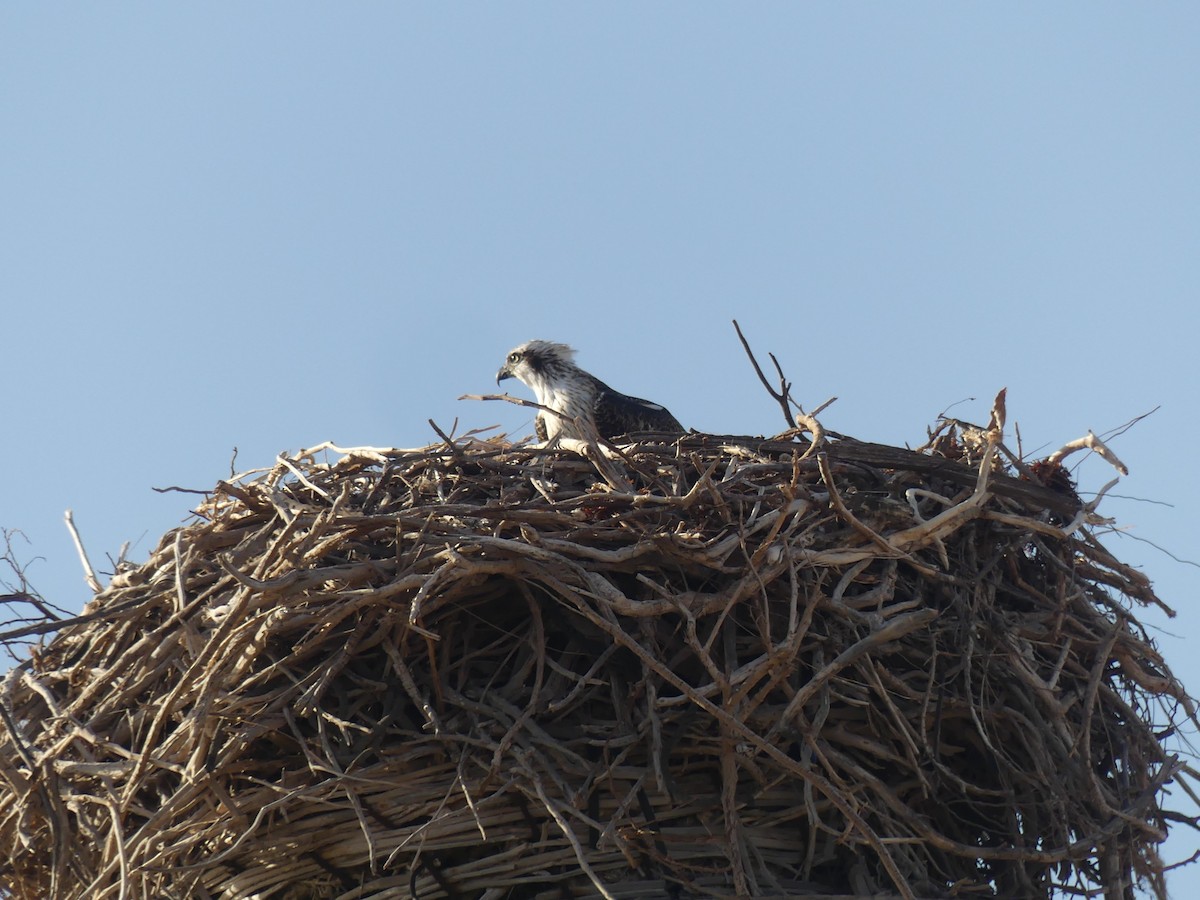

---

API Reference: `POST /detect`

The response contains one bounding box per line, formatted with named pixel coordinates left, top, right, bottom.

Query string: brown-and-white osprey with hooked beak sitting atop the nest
left=496, top=341, right=684, bottom=440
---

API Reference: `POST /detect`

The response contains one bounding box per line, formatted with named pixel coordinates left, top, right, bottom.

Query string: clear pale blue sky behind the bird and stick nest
left=0, top=2, right=1200, bottom=896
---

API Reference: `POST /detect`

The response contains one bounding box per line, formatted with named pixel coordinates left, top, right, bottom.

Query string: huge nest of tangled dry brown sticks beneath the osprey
left=0, top=424, right=1192, bottom=900
